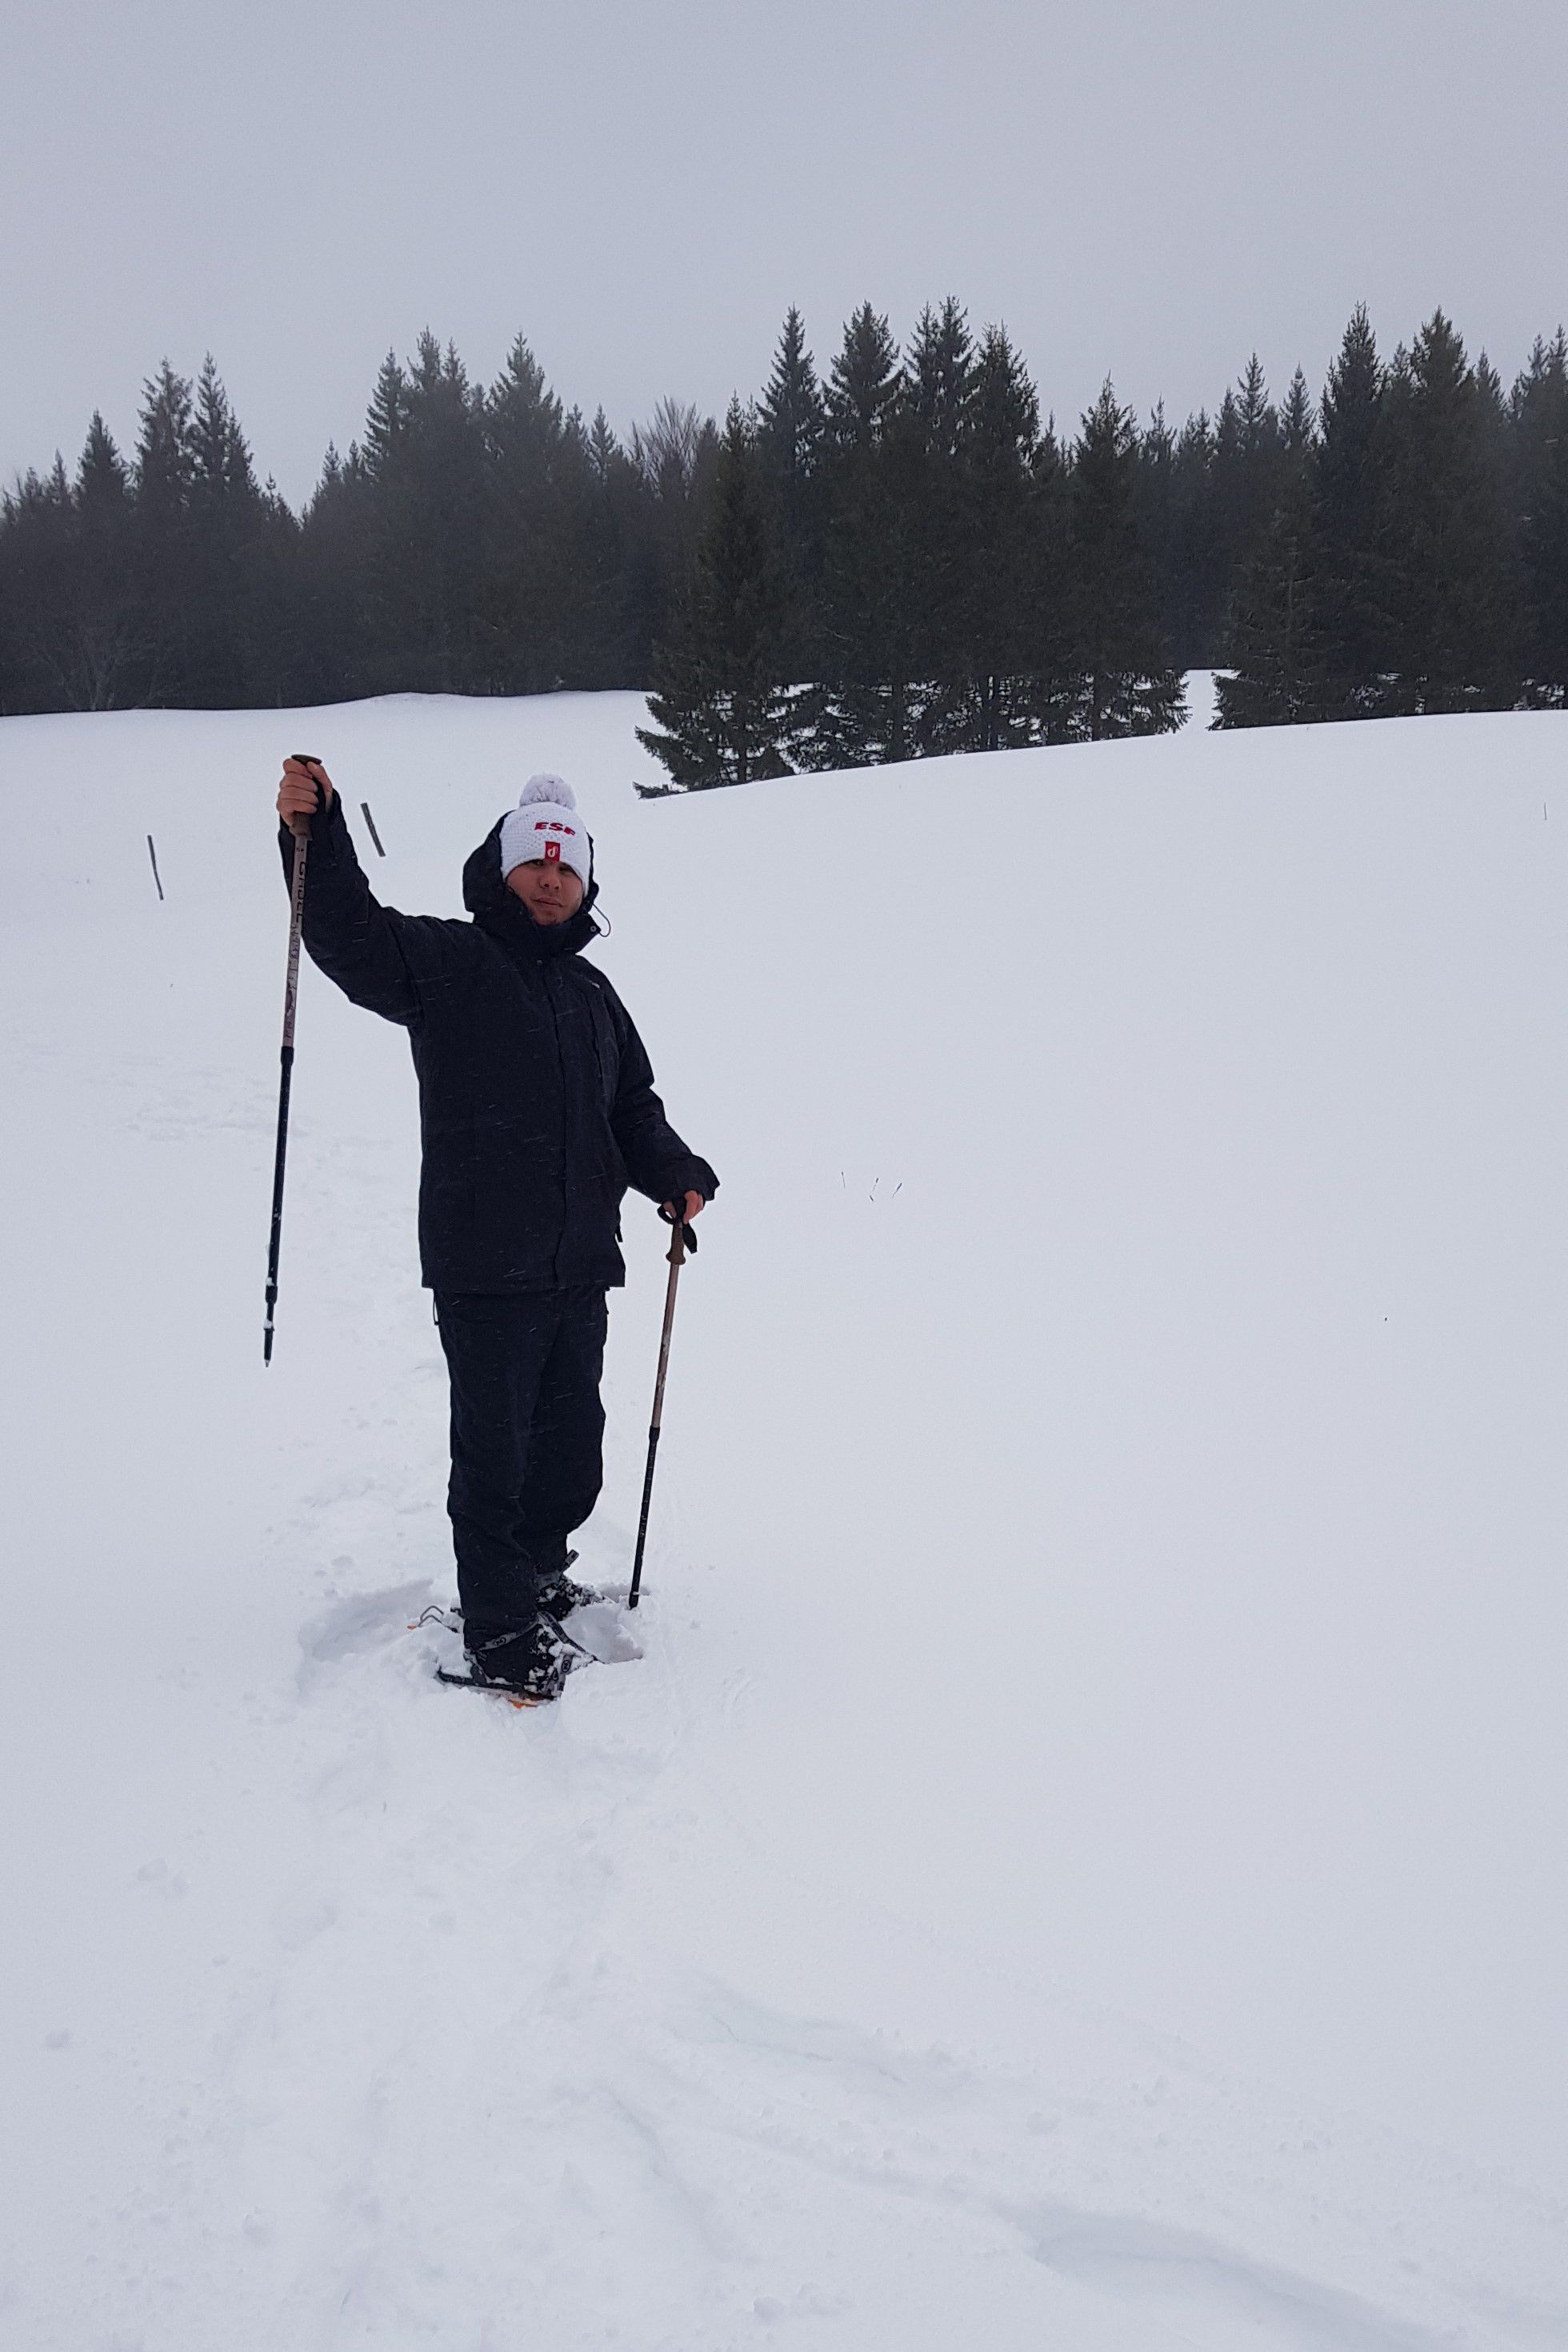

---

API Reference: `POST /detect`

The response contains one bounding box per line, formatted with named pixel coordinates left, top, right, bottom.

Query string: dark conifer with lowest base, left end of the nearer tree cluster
left=637, top=400, right=792, bottom=790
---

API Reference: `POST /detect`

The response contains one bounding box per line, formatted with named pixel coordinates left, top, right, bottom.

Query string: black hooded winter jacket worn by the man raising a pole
left=280, top=795, right=719, bottom=1291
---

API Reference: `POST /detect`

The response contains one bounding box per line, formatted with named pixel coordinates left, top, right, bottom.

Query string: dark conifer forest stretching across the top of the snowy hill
left=0, top=298, right=1568, bottom=790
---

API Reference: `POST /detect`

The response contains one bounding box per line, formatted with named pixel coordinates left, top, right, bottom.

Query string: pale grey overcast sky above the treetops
left=0, top=0, right=1568, bottom=501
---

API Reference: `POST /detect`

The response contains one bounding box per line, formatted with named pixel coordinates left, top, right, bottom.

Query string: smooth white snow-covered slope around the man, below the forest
left=0, top=696, right=1568, bottom=2352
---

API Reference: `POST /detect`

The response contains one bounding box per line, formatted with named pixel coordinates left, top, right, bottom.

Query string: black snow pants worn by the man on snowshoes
left=435, top=1286, right=606, bottom=1649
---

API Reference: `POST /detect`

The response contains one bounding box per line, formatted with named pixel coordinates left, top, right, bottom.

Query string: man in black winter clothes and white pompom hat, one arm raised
left=278, top=760, right=719, bottom=1698
